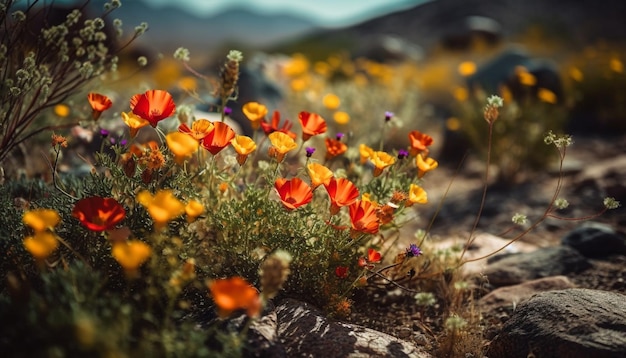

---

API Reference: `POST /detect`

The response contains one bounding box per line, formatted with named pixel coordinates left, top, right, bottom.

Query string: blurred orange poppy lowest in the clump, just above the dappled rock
left=209, top=277, right=261, bottom=318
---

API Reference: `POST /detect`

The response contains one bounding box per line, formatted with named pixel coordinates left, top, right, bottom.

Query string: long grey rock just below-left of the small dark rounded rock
left=484, top=246, right=591, bottom=287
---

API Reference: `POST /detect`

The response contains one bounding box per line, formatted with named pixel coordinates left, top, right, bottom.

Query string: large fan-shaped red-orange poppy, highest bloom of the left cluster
left=130, top=90, right=176, bottom=127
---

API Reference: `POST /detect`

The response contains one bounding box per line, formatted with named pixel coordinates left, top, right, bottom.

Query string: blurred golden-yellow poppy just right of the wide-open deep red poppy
left=137, top=189, right=185, bottom=229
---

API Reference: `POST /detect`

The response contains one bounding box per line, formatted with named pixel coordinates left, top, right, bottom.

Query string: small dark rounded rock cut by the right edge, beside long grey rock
left=561, top=222, right=626, bottom=258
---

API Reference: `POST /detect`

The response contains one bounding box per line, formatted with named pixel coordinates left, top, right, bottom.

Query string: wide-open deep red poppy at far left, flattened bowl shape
left=72, top=196, right=126, bottom=231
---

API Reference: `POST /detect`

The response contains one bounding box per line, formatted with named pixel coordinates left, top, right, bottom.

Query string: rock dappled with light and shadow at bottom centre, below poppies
left=276, top=299, right=431, bottom=358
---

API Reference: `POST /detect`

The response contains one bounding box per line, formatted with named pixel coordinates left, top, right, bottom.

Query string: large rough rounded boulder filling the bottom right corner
left=486, top=288, right=626, bottom=358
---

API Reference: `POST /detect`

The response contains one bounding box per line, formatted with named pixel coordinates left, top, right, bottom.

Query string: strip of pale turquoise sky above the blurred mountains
left=143, top=0, right=428, bottom=26
